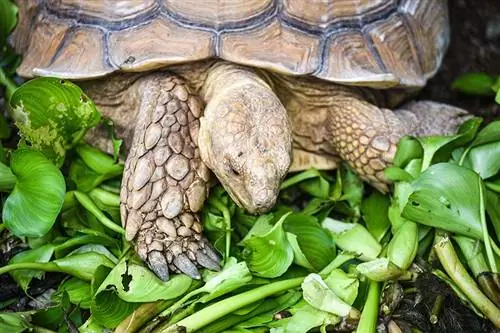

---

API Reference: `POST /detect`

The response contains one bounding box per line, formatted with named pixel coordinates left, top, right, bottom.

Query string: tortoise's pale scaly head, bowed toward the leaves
left=198, top=70, right=292, bottom=213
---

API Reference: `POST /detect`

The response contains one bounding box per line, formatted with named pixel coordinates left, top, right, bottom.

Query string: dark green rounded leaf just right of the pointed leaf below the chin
left=283, top=213, right=336, bottom=271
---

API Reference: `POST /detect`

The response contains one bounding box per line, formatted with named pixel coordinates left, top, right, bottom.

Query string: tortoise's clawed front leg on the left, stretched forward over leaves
left=120, top=73, right=220, bottom=280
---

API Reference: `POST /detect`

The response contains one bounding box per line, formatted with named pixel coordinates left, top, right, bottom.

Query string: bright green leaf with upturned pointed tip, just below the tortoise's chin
left=241, top=214, right=293, bottom=278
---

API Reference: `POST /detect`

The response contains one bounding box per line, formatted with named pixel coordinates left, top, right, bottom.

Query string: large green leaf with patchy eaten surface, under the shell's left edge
left=10, top=78, right=100, bottom=165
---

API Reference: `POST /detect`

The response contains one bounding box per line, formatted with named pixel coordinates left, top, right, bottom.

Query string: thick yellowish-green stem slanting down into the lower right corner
left=434, top=231, right=500, bottom=328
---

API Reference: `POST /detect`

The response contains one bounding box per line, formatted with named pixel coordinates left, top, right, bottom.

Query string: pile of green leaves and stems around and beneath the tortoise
left=0, top=1, right=500, bottom=333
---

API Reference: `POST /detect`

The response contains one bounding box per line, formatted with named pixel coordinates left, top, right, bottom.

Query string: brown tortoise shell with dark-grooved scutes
left=12, top=0, right=449, bottom=88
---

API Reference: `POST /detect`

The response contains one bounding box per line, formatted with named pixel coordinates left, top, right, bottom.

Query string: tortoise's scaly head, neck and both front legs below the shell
left=82, top=62, right=467, bottom=280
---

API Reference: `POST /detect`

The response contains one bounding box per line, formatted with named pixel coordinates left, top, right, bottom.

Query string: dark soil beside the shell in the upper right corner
left=420, top=0, right=500, bottom=121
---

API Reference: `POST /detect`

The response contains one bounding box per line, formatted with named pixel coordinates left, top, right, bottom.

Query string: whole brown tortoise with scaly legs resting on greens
left=11, top=0, right=468, bottom=280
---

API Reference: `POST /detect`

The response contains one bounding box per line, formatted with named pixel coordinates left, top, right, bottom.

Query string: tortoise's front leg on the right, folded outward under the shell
left=292, top=94, right=470, bottom=192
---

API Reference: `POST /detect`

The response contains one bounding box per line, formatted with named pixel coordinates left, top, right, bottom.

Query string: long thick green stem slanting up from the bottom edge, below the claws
left=154, top=277, right=304, bottom=333
